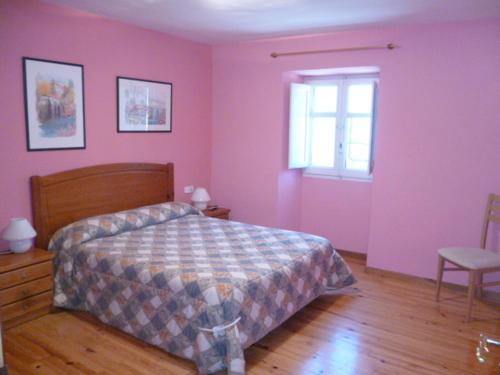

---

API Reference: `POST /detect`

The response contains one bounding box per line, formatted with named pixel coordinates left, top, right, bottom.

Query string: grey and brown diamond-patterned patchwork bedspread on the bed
left=49, top=203, right=355, bottom=374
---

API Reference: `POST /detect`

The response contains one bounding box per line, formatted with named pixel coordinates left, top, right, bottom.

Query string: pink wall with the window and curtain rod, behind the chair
left=212, top=20, right=500, bottom=280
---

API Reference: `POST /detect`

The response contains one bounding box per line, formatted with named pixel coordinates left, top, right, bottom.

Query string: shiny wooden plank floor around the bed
left=5, top=258, right=500, bottom=375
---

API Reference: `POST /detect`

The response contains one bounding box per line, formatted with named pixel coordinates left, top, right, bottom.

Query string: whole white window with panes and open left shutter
left=289, top=75, right=378, bottom=179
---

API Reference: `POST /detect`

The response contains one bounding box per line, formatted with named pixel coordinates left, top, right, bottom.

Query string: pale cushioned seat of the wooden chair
left=438, top=247, right=500, bottom=270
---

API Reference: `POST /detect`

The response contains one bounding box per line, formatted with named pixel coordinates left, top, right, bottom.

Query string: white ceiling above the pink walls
left=45, top=0, right=500, bottom=44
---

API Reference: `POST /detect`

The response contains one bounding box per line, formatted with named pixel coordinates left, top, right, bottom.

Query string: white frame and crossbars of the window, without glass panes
left=303, top=74, right=379, bottom=181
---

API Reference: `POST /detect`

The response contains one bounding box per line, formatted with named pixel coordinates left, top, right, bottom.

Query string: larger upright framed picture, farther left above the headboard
left=23, top=57, right=85, bottom=151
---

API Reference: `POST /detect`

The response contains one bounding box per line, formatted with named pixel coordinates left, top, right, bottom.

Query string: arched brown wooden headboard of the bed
left=31, top=163, right=174, bottom=249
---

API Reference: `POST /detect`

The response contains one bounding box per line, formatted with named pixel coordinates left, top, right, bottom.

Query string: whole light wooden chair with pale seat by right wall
left=436, top=194, right=500, bottom=322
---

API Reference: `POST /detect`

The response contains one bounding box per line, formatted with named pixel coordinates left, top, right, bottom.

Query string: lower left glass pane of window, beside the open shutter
left=311, top=117, right=336, bottom=168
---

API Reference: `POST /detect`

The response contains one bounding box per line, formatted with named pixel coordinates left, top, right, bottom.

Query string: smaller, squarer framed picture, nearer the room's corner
left=116, top=77, right=172, bottom=133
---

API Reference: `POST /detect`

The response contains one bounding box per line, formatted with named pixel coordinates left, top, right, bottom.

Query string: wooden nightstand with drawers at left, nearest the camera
left=0, top=248, right=54, bottom=328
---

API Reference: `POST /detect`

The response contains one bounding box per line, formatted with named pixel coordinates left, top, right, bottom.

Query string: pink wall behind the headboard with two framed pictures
left=0, top=1, right=212, bottom=251
